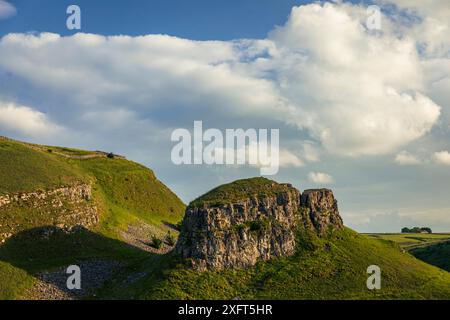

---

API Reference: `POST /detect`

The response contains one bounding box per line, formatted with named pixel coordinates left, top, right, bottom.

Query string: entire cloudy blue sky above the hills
left=0, top=0, right=450, bottom=232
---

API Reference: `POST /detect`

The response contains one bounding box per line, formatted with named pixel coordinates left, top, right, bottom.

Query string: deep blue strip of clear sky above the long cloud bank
left=0, top=0, right=316, bottom=40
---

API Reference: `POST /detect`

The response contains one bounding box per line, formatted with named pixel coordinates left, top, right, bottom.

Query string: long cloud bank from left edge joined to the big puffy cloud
left=0, top=3, right=441, bottom=156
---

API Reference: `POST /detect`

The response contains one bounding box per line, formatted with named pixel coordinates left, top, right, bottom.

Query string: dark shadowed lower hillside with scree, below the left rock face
left=0, top=226, right=163, bottom=299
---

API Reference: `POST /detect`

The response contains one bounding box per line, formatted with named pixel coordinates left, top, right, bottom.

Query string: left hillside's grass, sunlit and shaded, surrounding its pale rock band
left=0, top=139, right=185, bottom=299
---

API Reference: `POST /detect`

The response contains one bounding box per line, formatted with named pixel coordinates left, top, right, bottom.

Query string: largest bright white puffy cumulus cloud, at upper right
left=271, top=3, right=440, bottom=156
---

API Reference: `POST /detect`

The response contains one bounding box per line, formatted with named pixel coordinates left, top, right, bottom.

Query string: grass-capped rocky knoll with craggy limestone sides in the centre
left=176, top=178, right=342, bottom=270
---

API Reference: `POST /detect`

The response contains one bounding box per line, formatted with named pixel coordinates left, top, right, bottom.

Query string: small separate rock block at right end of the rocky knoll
left=300, top=189, right=343, bottom=233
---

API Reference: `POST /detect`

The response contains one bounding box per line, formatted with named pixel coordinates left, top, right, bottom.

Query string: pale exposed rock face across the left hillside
left=0, top=184, right=98, bottom=242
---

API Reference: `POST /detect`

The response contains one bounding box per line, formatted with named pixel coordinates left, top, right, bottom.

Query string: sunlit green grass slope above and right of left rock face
left=0, top=139, right=185, bottom=234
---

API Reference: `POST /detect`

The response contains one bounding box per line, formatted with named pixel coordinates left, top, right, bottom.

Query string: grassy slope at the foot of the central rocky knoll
left=101, top=229, right=450, bottom=299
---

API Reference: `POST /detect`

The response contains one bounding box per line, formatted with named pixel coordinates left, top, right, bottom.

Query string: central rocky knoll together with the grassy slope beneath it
left=110, top=178, right=450, bottom=299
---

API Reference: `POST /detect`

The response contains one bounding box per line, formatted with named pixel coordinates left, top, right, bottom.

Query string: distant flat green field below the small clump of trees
left=368, top=233, right=450, bottom=251
